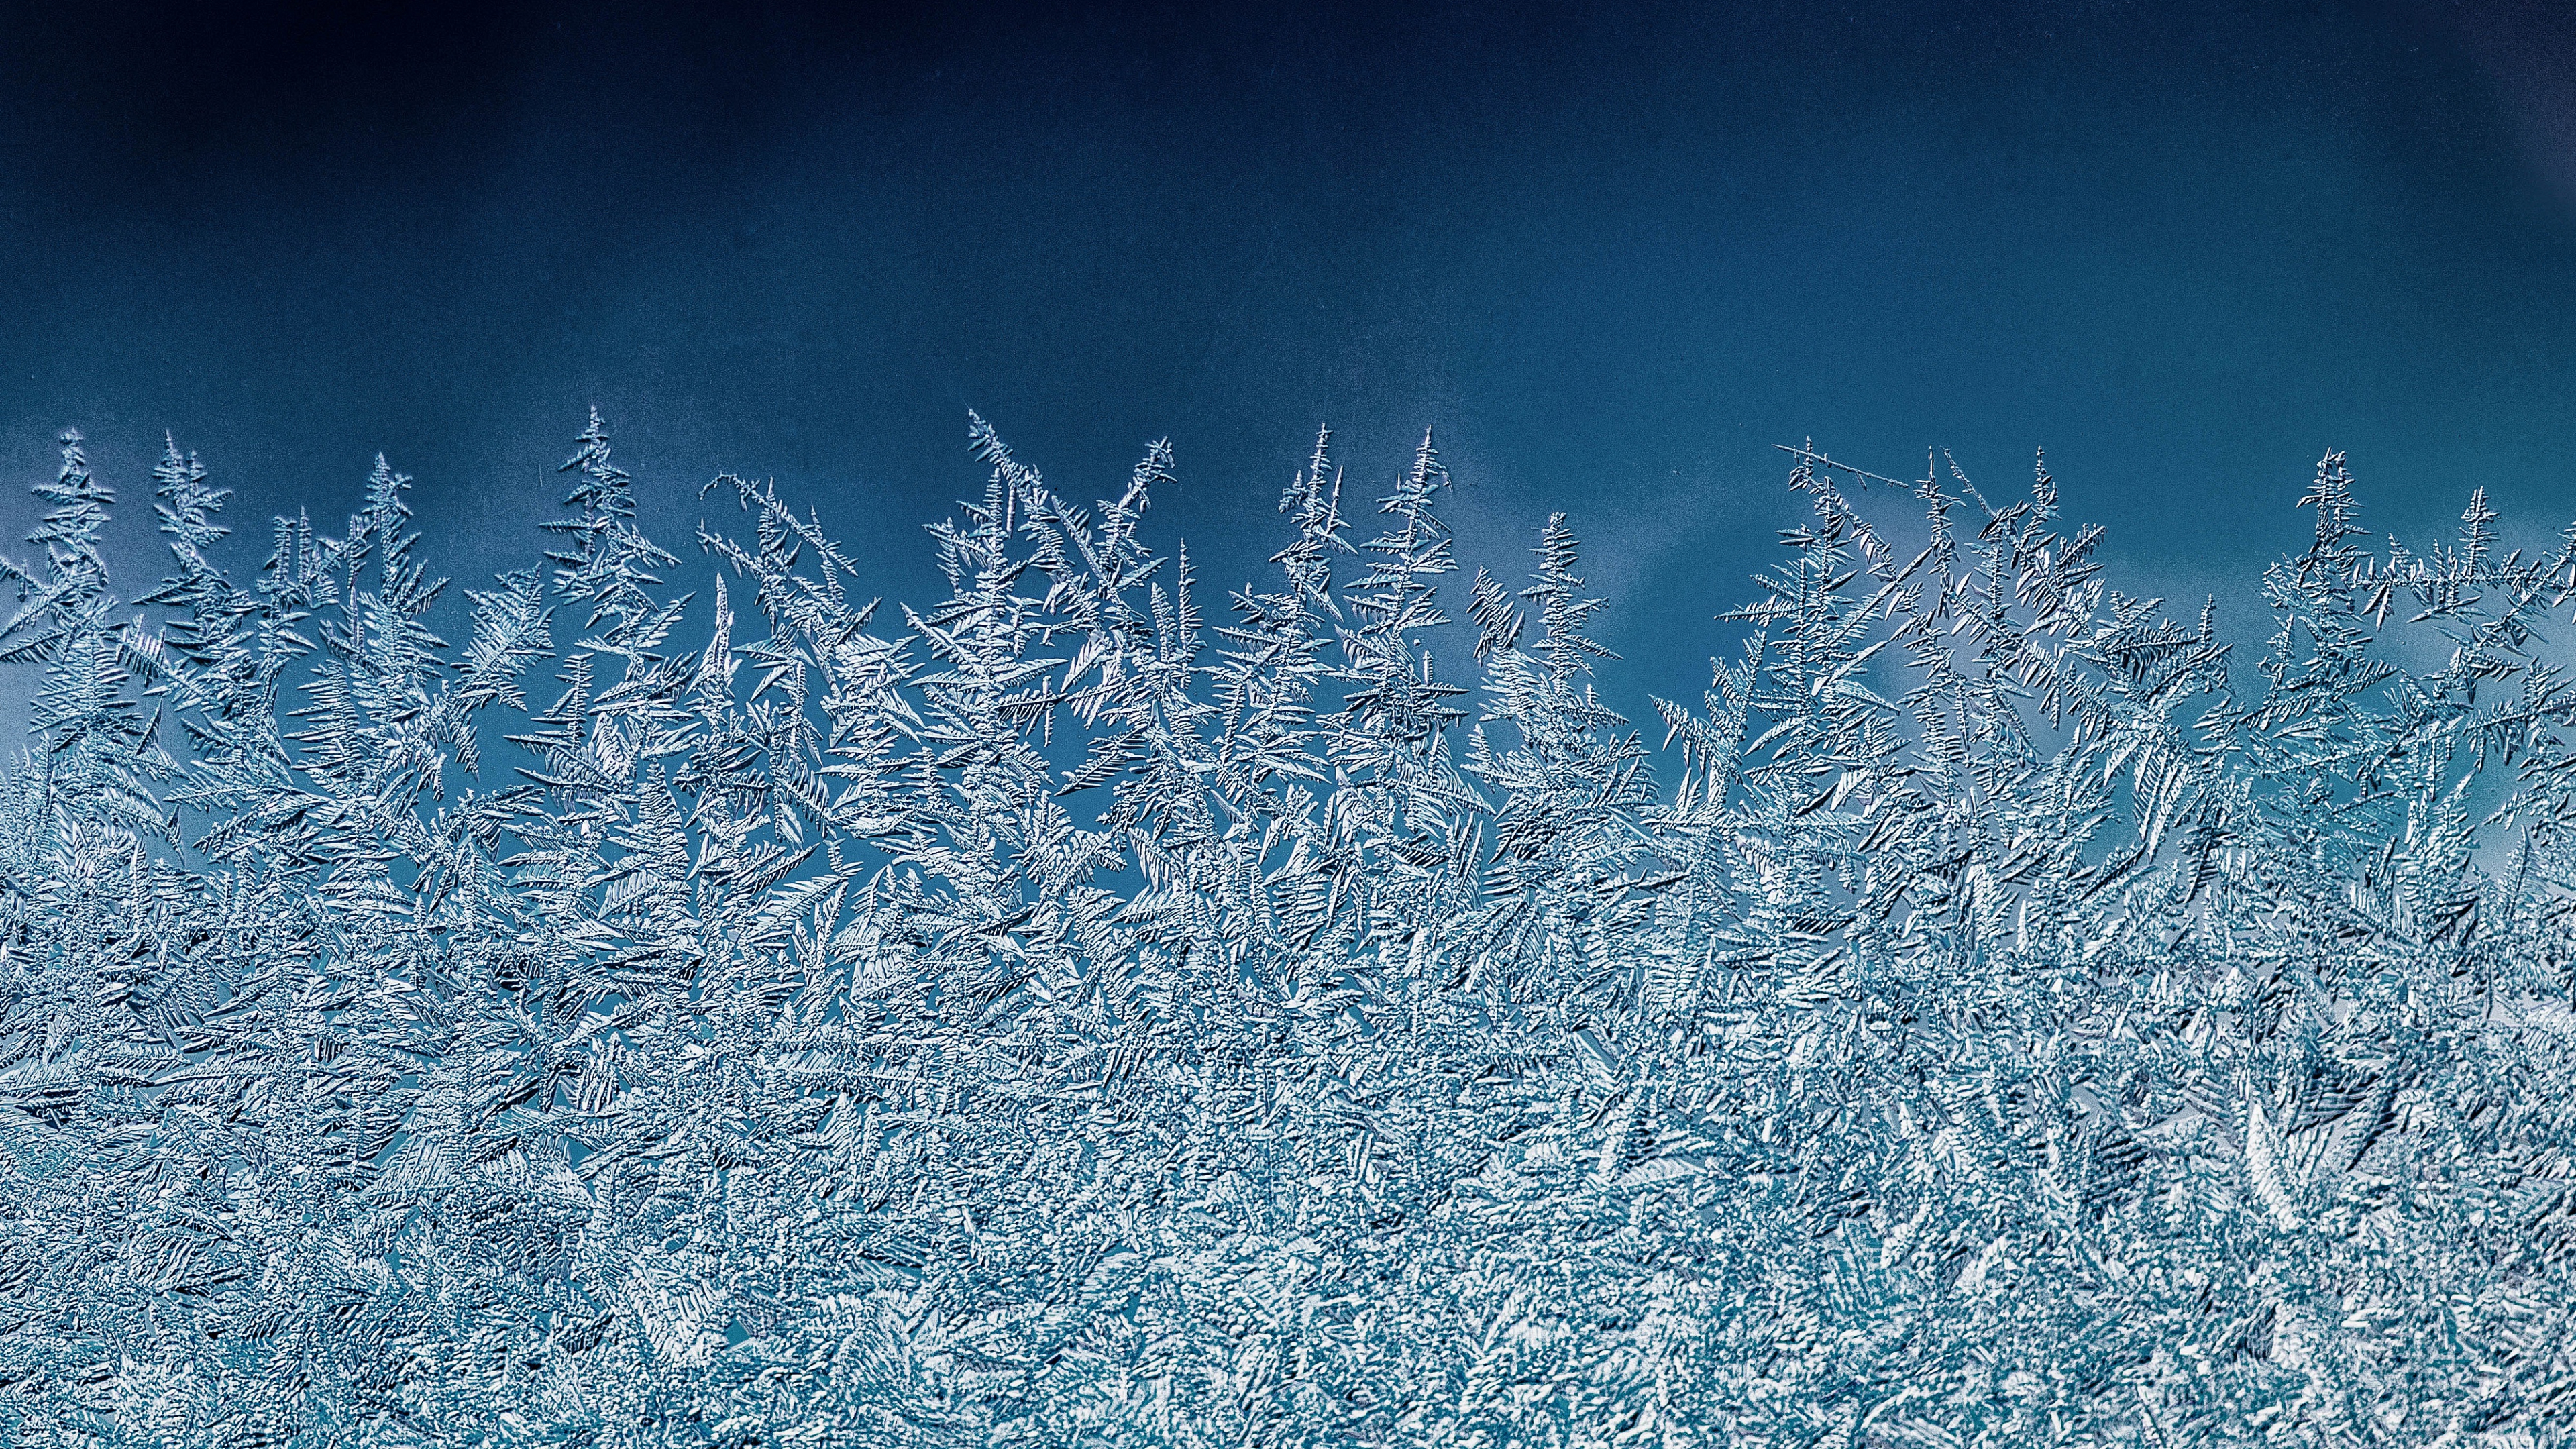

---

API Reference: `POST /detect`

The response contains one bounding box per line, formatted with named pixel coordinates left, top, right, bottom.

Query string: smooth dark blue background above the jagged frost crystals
left=0, top=0, right=2576, bottom=714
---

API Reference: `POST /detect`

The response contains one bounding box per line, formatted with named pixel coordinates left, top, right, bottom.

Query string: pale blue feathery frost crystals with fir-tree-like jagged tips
left=0, top=420, right=2576, bottom=1449
